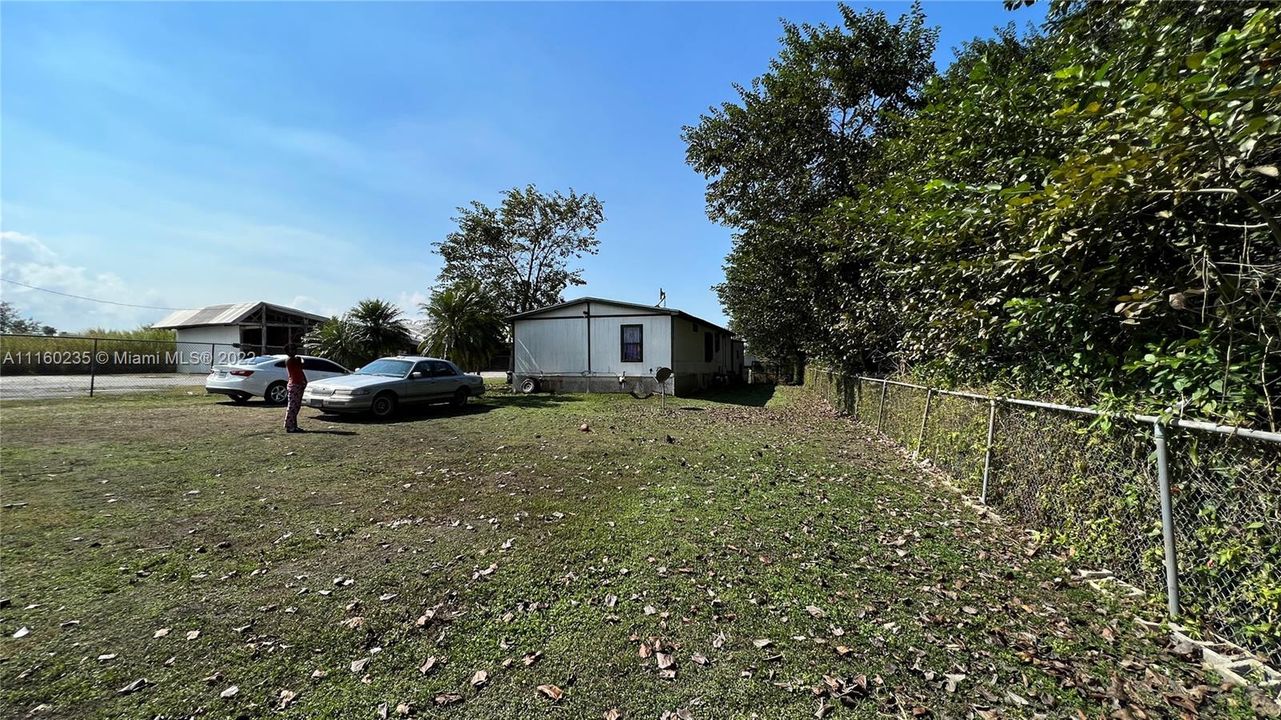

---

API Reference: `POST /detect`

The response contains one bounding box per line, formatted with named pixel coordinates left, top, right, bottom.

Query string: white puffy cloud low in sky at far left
left=0, top=231, right=164, bottom=332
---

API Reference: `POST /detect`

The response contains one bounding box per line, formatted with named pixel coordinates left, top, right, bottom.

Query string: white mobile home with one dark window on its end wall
left=510, top=297, right=743, bottom=396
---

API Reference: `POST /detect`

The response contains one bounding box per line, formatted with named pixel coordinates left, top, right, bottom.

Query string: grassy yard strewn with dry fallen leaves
left=0, top=388, right=1259, bottom=719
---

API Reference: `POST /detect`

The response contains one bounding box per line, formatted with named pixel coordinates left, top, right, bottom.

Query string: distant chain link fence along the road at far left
left=0, top=334, right=260, bottom=400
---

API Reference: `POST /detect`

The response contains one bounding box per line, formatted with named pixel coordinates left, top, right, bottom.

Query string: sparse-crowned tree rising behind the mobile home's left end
left=433, top=184, right=605, bottom=315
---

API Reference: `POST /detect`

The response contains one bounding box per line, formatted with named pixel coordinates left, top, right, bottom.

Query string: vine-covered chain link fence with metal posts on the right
left=806, top=368, right=1281, bottom=664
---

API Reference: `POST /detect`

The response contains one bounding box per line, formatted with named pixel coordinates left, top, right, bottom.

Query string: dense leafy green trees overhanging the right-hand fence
left=828, top=3, right=1281, bottom=427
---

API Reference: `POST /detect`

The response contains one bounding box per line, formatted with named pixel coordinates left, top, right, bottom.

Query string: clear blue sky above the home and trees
left=0, top=1, right=1044, bottom=329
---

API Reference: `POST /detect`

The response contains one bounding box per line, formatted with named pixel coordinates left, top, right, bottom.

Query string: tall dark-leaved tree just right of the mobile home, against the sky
left=684, top=5, right=938, bottom=360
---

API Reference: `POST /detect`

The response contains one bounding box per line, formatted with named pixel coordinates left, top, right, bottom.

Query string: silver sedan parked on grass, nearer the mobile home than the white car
left=302, top=356, right=484, bottom=418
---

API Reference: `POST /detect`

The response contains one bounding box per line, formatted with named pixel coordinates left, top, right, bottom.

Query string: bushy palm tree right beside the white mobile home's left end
left=419, top=281, right=506, bottom=370
